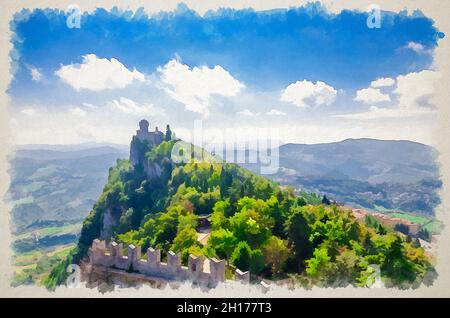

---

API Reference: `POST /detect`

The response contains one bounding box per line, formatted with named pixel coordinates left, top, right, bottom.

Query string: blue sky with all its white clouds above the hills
left=9, top=4, right=443, bottom=143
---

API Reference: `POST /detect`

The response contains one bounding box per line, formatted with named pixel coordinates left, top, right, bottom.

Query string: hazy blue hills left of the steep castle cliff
left=8, top=145, right=128, bottom=232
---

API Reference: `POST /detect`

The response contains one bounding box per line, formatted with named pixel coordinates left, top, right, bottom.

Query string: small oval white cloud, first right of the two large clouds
left=280, top=80, right=337, bottom=107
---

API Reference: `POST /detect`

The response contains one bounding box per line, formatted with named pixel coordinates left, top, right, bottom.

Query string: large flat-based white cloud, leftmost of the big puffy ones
left=55, top=54, right=145, bottom=91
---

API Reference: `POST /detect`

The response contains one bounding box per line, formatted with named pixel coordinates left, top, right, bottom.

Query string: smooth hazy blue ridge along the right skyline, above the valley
left=280, top=139, right=439, bottom=183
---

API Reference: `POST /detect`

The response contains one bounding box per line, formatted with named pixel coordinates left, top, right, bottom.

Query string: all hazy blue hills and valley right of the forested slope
left=243, top=139, right=441, bottom=215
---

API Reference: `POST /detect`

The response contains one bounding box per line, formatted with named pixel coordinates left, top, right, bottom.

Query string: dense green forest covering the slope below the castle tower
left=46, top=130, right=434, bottom=289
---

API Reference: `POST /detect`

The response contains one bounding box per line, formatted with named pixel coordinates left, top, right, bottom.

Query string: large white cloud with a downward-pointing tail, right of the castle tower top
left=157, top=59, right=245, bottom=117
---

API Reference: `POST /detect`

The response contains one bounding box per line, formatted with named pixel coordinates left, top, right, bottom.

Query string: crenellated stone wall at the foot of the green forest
left=90, top=239, right=250, bottom=287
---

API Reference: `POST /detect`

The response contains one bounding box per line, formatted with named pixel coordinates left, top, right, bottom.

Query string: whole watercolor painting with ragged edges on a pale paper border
left=5, top=2, right=445, bottom=292
